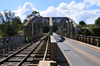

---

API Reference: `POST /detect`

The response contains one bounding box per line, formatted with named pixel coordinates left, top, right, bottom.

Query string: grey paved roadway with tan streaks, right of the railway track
left=53, top=33, right=100, bottom=66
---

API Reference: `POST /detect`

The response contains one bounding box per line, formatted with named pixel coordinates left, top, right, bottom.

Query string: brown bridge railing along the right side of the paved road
left=60, top=33, right=100, bottom=47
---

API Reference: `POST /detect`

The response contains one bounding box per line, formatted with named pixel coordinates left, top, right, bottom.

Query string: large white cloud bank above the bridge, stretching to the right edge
left=40, top=1, right=100, bottom=24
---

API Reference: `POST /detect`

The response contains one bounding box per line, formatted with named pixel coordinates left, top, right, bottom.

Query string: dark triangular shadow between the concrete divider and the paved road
left=57, top=46, right=70, bottom=66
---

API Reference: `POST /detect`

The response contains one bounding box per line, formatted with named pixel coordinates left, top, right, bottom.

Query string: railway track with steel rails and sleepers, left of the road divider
left=0, top=36, right=50, bottom=66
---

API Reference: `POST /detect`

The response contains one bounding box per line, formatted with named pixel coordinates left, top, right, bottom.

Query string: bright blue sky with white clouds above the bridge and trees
left=0, top=0, right=100, bottom=24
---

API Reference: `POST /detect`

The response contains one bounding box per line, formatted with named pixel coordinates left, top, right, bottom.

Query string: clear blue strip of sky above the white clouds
left=0, top=0, right=83, bottom=11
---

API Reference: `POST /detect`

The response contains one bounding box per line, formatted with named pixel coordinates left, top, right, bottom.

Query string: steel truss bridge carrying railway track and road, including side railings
left=0, top=17, right=100, bottom=66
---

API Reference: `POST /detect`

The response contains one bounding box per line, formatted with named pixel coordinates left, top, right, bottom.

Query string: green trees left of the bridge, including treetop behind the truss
left=0, top=10, right=45, bottom=38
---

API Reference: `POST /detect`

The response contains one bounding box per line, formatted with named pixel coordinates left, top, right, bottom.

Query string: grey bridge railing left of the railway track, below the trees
left=0, top=35, right=24, bottom=53
